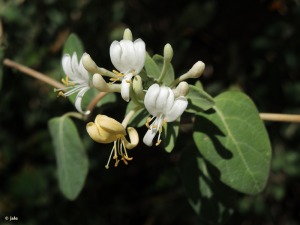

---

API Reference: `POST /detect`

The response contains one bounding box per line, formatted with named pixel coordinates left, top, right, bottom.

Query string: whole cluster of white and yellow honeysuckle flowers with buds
left=59, top=29, right=204, bottom=168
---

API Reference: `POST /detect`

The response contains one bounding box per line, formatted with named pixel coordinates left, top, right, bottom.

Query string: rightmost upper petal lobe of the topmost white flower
left=133, top=38, right=146, bottom=74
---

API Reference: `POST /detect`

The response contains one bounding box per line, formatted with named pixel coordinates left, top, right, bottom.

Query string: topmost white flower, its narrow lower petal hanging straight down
left=109, top=39, right=146, bottom=102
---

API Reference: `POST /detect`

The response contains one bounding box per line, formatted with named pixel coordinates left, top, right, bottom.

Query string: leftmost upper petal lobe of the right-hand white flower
left=144, top=84, right=160, bottom=116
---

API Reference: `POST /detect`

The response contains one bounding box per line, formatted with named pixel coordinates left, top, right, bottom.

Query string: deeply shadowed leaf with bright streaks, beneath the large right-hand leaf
left=179, top=142, right=236, bottom=225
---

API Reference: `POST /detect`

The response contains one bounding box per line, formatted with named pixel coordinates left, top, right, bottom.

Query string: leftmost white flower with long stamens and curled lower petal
left=59, top=52, right=91, bottom=114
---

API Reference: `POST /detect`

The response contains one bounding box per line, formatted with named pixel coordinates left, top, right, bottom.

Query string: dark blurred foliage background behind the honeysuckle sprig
left=0, top=0, right=300, bottom=225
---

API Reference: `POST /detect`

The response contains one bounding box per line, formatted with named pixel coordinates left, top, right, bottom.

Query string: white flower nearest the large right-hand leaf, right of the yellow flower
left=143, top=84, right=188, bottom=146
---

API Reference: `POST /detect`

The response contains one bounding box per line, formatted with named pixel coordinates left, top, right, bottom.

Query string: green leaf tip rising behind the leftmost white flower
left=63, top=33, right=84, bottom=59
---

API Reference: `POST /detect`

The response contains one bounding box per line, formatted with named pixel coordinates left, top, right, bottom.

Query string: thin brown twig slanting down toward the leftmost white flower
left=3, top=59, right=65, bottom=89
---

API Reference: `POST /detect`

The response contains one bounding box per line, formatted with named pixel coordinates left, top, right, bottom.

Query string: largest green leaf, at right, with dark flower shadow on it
left=193, top=91, right=271, bottom=194
